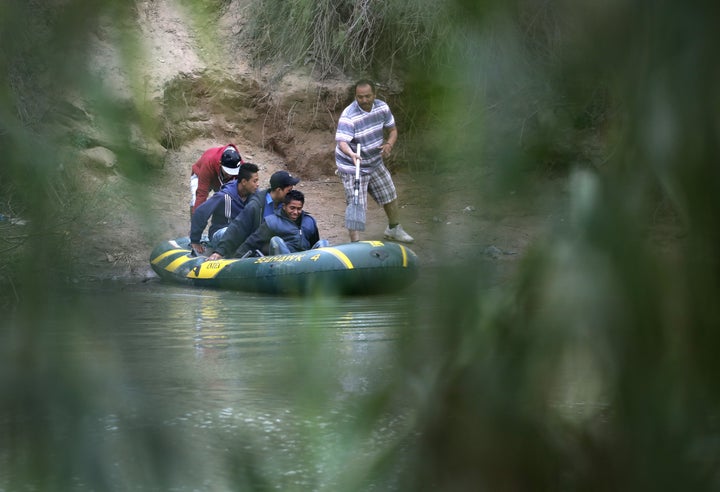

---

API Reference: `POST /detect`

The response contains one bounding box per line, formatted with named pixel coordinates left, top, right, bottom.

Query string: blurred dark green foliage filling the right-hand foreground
left=390, top=2, right=720, bottom=490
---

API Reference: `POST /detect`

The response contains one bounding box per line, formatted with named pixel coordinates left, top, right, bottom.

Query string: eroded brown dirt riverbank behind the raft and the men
left=69, top=0, right=563, bottom=279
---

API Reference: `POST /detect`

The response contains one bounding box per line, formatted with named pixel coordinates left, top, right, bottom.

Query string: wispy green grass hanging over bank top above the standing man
left=247, top=0, right=451, bottom=79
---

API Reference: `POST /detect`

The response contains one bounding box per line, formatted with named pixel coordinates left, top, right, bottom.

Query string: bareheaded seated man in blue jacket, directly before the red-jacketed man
left=190, top=162, right=259, bottom=254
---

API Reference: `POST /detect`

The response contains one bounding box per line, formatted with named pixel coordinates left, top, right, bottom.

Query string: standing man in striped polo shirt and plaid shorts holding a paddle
left=335, top=79, right=413, bottom=243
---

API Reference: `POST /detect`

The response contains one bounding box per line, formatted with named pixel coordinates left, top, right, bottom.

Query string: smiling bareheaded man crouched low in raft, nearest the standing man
left=238, top=190, right=328, bottom=256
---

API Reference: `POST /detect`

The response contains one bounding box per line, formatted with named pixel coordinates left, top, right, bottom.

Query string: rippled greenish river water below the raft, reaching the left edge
left=0, top=266, right=602, bottom=492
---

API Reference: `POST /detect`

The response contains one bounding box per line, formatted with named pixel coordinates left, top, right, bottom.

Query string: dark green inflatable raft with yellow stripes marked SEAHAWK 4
left=150, top=237, right=418, bottom=295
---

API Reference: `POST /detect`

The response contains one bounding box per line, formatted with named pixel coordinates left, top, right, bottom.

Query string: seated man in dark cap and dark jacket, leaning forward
left=208, top=171, right=300, bottom=260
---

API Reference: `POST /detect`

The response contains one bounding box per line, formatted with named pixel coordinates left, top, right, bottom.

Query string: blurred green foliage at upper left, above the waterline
left=0, top=0, right=159, bottom=300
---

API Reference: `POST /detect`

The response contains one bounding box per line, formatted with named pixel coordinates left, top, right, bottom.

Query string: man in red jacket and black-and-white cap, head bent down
left=190, top=140, right=243, bottom=216
